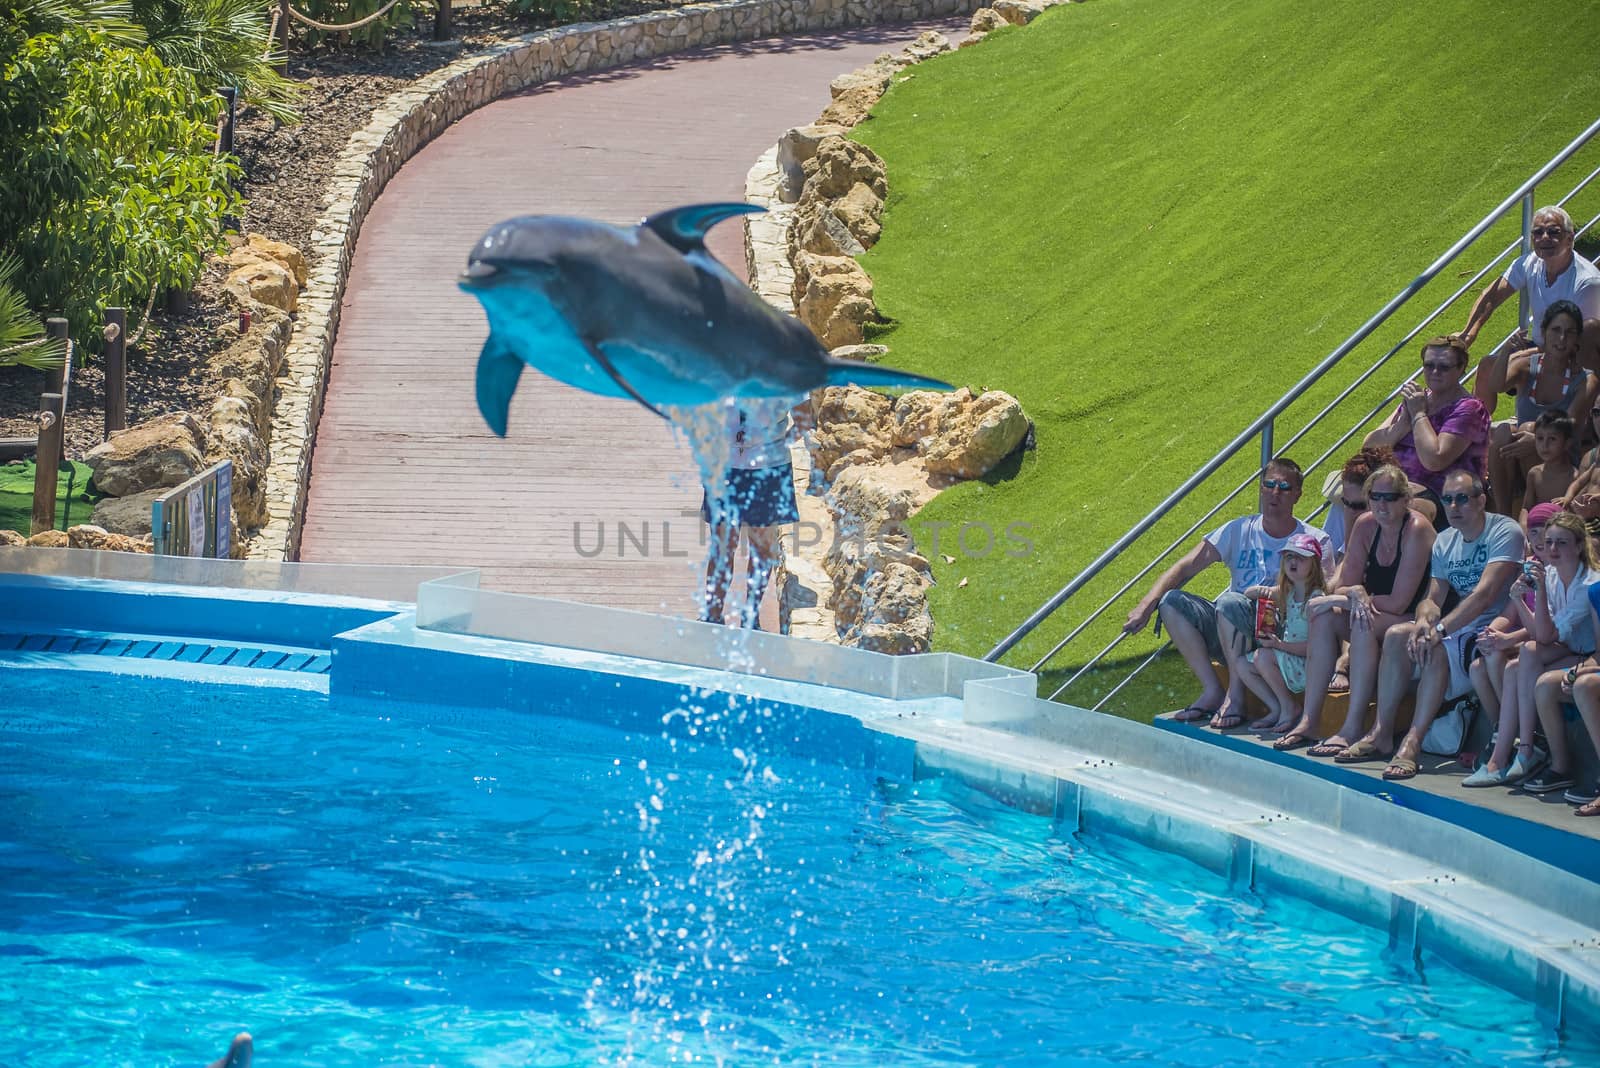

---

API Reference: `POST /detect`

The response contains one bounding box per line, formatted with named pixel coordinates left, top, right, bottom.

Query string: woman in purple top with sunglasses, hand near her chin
left=1363, top=334, right=1490, bottom=531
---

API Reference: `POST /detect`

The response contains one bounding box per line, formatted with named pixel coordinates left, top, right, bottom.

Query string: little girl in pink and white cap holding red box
left=1240, top=534, right=1342, bottom=734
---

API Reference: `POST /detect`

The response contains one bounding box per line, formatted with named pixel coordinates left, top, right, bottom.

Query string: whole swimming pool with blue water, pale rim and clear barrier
left=0, top=553, right=1600, bottom=1065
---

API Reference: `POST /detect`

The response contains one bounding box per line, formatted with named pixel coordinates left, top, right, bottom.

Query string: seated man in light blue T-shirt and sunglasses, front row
left=1333, top=470, right=1523, bottom=779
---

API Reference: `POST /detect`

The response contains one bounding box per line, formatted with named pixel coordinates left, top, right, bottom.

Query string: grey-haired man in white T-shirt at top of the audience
left=1461, top=208, right=1600, bottom=388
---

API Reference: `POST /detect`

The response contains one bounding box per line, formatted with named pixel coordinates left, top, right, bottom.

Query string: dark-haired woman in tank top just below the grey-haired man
left=1474, top=301, right=1600, bottom=515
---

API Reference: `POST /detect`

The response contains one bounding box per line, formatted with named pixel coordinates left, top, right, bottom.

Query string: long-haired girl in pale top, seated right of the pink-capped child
left=1461, top=512, right=1597, bottom=787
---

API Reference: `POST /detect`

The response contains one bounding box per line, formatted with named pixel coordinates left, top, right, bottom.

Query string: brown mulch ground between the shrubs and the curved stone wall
left=0, top=0, right=675, bottom=457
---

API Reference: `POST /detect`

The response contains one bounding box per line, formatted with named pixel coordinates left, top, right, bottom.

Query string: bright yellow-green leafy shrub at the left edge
left=0, top=26, right=240, bottom=345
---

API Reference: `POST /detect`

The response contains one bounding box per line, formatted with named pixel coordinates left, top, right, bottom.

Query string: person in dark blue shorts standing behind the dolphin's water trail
left=701, top=398, right=800, bottom=630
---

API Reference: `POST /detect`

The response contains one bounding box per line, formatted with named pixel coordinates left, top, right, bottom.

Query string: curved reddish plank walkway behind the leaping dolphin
left=301, top=19, right=965, bottom=614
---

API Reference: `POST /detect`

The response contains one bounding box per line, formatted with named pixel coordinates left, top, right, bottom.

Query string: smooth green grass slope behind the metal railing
left=854, top=0, right=1600, bottom=716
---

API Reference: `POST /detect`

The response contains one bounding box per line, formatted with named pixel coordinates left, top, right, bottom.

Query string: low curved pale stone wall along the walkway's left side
left=246, top=0, right=981, bottom=560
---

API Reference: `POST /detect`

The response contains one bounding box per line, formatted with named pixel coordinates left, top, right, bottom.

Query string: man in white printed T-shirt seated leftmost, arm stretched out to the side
left=1123, top=456, right=1333, bottom=731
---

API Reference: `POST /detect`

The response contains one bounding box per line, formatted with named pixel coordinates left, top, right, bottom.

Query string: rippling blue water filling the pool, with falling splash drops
left=0, top=671, right=1600, bottom=1068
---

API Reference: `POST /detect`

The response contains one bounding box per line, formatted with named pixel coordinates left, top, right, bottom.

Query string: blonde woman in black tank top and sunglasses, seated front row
left=1274, top=464, right=1434, bottom=756
